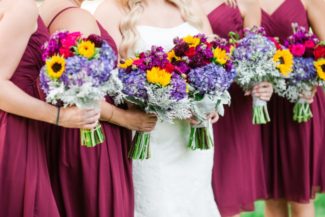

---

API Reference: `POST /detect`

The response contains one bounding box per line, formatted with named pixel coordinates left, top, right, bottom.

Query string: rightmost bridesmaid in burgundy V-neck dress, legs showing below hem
left=260, top=0, right=325, bottom=217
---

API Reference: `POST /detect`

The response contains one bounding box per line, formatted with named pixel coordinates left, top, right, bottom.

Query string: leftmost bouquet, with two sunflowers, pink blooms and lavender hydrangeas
left=40, top=31, right=116, bottom=147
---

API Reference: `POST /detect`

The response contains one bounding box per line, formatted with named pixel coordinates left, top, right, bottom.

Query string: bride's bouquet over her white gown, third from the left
left=168, top=34, right=235, bottom=150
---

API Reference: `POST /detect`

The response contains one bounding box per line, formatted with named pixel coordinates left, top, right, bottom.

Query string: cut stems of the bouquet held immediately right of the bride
left=253, top=96, right=271, bottom=124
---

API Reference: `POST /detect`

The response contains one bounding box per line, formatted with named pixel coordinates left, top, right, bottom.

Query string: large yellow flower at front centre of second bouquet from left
left=147, top=67, right=172, bottom=87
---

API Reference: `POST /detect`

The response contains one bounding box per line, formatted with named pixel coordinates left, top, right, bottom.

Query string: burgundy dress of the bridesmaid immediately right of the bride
left=208, top=4, right=266, bottom=217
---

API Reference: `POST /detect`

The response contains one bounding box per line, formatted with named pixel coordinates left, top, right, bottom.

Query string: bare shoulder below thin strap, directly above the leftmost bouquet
left=50, top=8, right=100, bottom=35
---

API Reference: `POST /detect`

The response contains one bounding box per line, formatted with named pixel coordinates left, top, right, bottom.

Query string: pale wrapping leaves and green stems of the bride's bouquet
left=187, top=94, right=215, bottom=150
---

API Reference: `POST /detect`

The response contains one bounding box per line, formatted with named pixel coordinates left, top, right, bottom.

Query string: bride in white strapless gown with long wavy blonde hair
left=95, top=0, right=220, bottom=217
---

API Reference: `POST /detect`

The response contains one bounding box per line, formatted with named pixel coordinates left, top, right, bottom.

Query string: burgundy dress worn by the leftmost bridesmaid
left=0, top=18, right=59, bottom=217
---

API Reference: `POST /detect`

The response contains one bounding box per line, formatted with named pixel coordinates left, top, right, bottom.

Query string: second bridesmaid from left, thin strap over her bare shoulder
left=41, top=0, right=156, bottom=217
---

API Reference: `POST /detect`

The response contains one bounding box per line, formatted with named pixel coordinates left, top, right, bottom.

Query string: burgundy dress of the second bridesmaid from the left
left=45, top=8, right=134, bottom=217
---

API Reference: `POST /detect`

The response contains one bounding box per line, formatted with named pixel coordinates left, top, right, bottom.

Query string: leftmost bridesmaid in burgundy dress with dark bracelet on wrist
left=0, top=0, right=99, bottom=217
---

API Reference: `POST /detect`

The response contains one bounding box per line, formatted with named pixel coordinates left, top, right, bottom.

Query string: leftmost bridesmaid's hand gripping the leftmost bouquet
left=59, top=107, right=100, bottom=129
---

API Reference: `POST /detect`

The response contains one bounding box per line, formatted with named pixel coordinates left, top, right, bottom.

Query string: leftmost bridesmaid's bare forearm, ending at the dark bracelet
left=0, top=81, right=57, bottom=124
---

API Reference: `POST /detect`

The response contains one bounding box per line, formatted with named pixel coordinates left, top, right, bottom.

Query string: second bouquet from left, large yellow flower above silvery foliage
left=118, top=46, right=191, bottom=160
